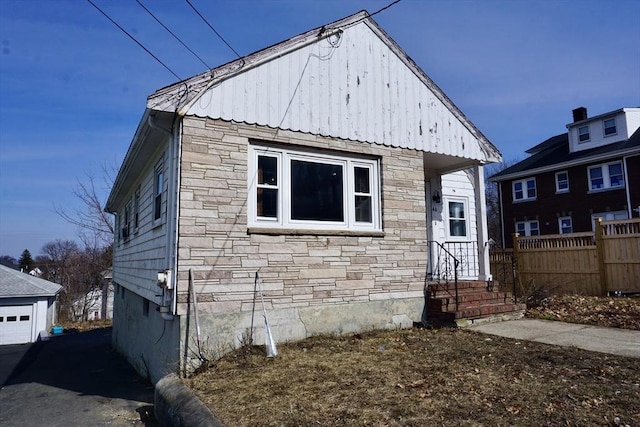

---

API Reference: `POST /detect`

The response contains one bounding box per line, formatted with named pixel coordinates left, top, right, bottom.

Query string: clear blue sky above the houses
left=0, top=0, right=640, bottom=258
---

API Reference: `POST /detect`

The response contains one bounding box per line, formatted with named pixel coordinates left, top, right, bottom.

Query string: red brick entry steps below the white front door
left=427, top=281, right=527, bottom=327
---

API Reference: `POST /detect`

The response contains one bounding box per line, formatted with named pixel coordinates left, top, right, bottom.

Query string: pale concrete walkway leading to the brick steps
left=469, top=319, right=640, bottom=358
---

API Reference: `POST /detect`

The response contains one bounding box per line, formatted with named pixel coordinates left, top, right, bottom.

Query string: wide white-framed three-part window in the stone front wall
left=248, top=144, right=381, bottom=231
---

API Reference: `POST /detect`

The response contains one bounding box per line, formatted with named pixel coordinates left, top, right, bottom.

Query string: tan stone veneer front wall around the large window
left=178, top=117, right=427, bottom=362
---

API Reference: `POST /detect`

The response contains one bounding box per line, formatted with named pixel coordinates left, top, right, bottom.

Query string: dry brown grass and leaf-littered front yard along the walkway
left=186, top=299, right=640, bottom=426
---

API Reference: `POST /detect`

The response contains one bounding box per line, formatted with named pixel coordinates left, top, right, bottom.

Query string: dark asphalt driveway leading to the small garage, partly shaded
left=0, top=328, right=157, bottom=427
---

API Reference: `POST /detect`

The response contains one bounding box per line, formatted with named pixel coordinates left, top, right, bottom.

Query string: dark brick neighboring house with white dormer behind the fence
left=489, top=107, right=640, bottom=247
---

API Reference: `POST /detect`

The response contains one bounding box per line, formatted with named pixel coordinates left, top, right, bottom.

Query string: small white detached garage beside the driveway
left=0, top=265, right=62, bottom=345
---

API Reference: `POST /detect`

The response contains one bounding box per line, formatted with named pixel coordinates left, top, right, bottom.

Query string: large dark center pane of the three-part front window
left=291, top=160, right=344, bottom=222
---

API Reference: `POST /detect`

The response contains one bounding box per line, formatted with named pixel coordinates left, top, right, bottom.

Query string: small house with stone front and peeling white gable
left=106, top=11, right=516, bottom=381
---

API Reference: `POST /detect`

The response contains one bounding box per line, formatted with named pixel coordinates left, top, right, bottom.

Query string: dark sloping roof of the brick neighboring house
left=489, top=129, right=640, bottom=182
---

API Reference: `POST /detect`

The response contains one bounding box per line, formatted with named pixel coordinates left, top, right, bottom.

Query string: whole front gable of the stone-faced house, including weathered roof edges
left=147, top=11, right=501, bottom=163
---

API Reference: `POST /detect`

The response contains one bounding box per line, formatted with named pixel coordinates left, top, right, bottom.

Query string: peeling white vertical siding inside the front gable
left=187, top=22, right=487, bottom=164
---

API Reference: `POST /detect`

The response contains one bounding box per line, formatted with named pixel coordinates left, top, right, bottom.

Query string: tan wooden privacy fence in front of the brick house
left=490, top=218, right=640, bottom=295
